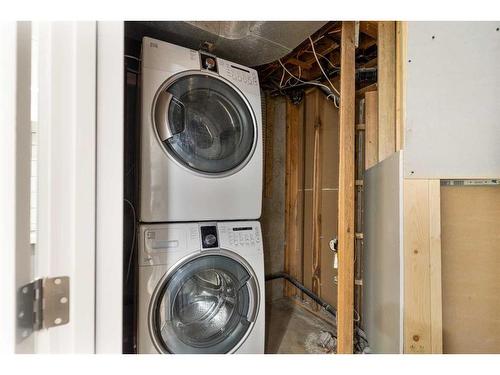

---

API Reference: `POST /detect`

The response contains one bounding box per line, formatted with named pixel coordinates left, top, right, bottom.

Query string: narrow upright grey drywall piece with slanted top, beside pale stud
left=363, top=152, right=403, bottom=353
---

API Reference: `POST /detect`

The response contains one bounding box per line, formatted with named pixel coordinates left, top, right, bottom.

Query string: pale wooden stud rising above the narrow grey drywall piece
left=377, top=21, right=396, bottom=161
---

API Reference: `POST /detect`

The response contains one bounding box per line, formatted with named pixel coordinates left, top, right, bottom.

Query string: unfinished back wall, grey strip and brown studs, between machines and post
left=261, top=89, right=339, bottom=309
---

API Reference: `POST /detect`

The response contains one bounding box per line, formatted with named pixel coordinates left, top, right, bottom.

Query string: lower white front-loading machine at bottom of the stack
left=137, top=221, right=265, bottom=354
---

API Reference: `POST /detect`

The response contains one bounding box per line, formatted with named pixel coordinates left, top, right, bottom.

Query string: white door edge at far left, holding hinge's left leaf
left=0, top=22, right=34, bottom=353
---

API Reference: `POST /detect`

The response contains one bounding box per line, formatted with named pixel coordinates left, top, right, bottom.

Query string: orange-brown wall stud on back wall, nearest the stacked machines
left=284, top=100, right=302, bottom=296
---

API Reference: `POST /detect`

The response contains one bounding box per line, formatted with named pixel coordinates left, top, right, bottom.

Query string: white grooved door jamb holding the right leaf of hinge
left=35, top=22, right=97, bottom=353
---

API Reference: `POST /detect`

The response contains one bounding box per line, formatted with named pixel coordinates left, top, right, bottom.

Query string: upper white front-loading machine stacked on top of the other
left=140, top=38, right=262, bottom=223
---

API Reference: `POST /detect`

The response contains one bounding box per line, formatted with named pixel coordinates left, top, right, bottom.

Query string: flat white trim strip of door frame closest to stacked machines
left=96, top=21, right=125, bottom=353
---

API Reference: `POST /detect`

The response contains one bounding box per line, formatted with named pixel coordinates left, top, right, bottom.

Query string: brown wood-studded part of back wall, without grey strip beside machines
left=278, top=89, right=339, bottom=309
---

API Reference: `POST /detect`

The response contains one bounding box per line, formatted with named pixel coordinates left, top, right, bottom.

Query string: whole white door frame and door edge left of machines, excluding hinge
left=0, top=22, right=124, bottom=353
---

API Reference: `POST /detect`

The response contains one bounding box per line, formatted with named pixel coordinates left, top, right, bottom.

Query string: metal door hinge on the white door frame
left=16, top=276, right=69, bottom=342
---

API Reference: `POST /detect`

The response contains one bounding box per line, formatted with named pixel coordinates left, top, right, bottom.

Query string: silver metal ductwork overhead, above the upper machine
left=130, top=21, right=326, bottom=66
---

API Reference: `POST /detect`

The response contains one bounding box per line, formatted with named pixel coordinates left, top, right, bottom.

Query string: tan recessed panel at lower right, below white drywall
left=441, top=186, right=500, bottom=353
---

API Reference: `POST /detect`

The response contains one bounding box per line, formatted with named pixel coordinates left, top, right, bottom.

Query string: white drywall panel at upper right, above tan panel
left=404, top=22, right=500, bottom=179
